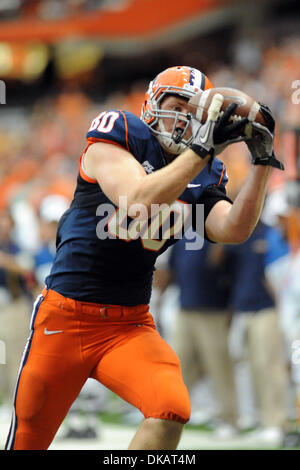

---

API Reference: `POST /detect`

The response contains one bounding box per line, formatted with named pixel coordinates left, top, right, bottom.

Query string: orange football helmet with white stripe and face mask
left=141, top=66, right=212, bottom=155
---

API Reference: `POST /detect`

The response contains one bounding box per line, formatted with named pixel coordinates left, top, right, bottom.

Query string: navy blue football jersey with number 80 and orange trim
left=46, top=110, right=228, bottom=306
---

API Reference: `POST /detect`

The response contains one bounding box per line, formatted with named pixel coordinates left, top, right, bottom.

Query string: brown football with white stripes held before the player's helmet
left=188, top=87, right=266, bottom=136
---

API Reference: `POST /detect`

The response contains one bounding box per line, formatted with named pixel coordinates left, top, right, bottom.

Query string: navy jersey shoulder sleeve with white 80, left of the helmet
left=86, top=110, right=147, bottom=159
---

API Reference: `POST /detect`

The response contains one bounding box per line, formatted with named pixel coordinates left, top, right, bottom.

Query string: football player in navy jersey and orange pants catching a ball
left=6, top=66, right=284, bottom=449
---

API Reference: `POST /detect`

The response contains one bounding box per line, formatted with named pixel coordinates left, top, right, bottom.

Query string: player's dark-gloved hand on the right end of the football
left=245, top=103, right=284, bottom=170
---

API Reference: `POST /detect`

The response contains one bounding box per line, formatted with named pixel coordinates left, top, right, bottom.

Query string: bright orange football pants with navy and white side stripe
left=6, top=289, right=190, bottom=450
